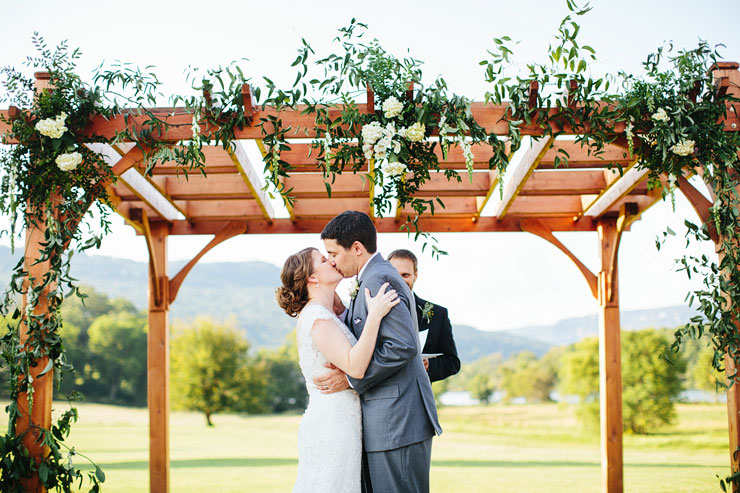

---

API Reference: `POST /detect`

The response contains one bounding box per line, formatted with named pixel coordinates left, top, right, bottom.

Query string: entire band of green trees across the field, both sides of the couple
left=3, top=288, right=722, bottom=433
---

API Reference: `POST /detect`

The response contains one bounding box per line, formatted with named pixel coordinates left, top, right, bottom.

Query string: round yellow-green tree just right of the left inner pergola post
left=170, top=318, right=266, bottom=426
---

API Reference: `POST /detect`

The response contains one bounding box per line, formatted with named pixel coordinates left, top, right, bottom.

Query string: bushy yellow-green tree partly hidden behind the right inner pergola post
left=560, top=329, right=686, bottom=433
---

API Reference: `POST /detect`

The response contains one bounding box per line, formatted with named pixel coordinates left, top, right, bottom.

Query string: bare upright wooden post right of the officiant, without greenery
left=598, top=218, right=624, bottom=493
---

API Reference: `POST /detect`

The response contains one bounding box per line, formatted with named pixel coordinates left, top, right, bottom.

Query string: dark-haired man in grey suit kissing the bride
left=314, top=211, right=442, bottom=493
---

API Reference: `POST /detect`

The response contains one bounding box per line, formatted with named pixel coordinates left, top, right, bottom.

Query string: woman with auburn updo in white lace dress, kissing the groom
left=277, top=248, right=399, bottom=493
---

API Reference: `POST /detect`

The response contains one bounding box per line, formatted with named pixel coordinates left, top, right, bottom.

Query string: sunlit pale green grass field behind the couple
left=49, top=403, right=729, bottom=493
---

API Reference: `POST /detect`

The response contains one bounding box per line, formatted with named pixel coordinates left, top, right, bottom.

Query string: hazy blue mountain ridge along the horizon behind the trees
left=0, top=246, right=696, bottom=362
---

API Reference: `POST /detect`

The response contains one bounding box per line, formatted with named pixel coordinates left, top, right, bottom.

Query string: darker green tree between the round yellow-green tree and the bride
left=258, top=331, right=308, bottom=413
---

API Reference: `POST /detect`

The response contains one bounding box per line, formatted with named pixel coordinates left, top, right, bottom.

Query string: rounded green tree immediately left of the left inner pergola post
left=87, top=311, right=146, bottom=404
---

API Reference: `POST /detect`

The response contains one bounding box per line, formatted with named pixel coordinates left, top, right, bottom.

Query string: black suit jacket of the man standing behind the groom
left=414, top=293, right=460, bottom=382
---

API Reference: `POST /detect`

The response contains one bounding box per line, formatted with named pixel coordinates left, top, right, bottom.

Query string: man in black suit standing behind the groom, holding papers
left=388, top=249, right=460, bottom=382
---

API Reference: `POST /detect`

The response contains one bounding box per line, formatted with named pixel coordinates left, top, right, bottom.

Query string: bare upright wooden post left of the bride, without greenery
left=144, top=220, right=170, bottom=493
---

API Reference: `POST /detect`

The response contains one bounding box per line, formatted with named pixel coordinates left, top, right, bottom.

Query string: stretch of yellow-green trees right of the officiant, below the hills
left=446, top=329, right=724, bottom=433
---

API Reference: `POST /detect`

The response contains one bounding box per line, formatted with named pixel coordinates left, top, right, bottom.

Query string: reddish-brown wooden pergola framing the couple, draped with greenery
left=0, top=63, right=740, bottom=493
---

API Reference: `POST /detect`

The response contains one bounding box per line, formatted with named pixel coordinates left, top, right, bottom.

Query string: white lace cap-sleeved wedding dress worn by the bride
left=293, top=304, right=362, bottom=493
